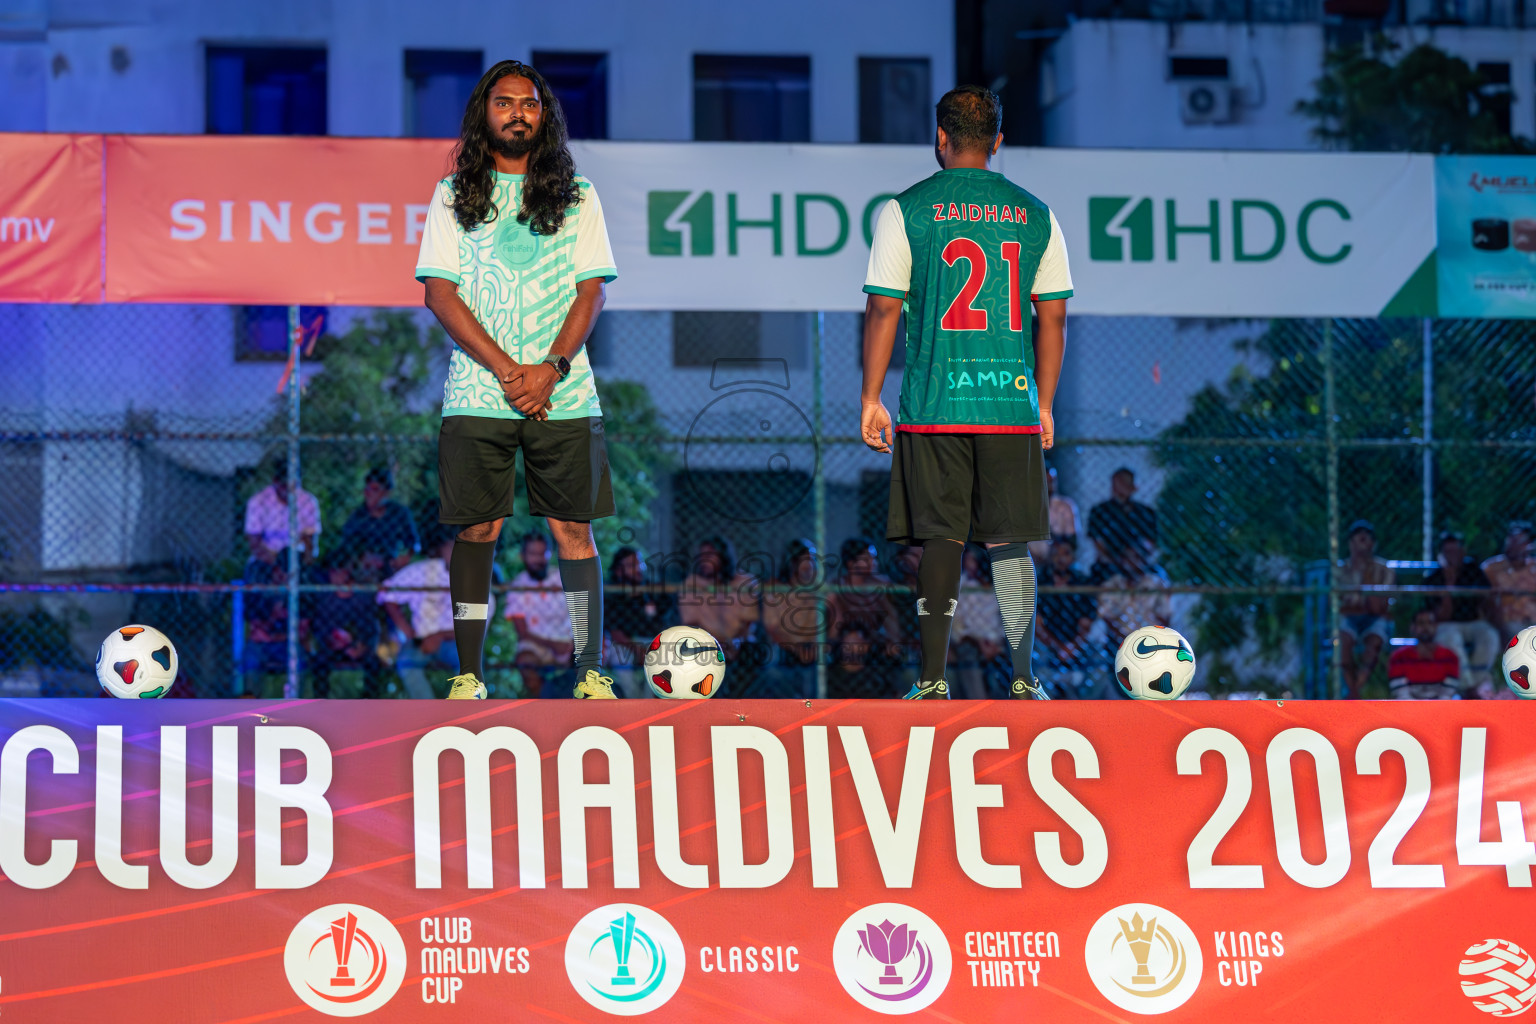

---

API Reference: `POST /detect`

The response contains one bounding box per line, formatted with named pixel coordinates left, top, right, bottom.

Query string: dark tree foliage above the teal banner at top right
left=1296, top=37, right=1536, bottom=154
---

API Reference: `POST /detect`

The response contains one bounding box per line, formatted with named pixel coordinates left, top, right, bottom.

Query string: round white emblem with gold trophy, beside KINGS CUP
left=1084, top=903, right=1204, bottom=1015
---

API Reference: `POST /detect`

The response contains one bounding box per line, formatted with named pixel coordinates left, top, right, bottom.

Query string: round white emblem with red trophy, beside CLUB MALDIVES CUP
left=283, top=903, right=406, bottom=1016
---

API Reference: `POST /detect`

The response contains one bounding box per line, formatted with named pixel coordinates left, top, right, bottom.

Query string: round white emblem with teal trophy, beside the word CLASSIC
left=565, top=903, right=687, bottom=1016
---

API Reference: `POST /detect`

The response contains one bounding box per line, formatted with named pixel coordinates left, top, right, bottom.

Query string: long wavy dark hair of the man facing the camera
left=453, top=60, right=581, bottom=235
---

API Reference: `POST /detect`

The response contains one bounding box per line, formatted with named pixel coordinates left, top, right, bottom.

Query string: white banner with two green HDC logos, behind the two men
left=573, top=143, right=1435, bottom=316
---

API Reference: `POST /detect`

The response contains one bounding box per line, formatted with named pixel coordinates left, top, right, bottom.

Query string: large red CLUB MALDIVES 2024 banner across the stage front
left=0, top=699, right=1536, bottom=1024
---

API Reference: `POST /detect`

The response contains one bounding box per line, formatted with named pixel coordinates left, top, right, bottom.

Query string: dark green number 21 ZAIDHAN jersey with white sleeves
left=863, top=167, right=1072, bottom=433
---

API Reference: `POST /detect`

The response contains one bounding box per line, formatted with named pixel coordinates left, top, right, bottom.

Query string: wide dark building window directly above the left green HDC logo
left=693, top=54, right=811, bottom=143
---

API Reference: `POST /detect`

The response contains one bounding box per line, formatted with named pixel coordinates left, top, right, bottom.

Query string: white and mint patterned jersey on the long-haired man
left=416, top=172, right=617, bottom=419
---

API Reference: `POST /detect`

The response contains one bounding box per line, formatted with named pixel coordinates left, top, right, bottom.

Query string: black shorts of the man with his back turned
left=885, top=430, right=1051, bottom=543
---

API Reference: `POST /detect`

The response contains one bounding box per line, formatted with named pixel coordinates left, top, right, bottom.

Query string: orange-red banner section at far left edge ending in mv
left=0, top=132, right=101, bottom=302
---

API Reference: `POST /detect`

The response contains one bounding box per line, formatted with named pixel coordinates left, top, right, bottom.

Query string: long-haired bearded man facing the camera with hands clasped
left=416, top=60, right=617, bottom=700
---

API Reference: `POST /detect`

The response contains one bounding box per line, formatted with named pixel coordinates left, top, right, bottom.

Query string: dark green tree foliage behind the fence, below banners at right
left=1157, top=319, right=1536, bottom=689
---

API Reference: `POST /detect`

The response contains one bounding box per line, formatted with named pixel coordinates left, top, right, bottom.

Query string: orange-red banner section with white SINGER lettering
left=106, top=135, right=453, bottom=306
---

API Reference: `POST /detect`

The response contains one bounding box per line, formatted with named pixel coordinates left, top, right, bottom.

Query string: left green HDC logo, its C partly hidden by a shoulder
left=645, top=189, right=894, bottom=256
